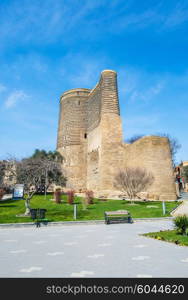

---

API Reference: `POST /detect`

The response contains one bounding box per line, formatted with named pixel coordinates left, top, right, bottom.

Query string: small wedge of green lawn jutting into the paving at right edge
left=144, top=230, right=188, bottom=246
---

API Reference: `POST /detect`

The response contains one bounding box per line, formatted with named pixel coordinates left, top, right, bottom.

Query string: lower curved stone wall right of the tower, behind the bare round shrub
left=124, top=136, right=176, bottom=200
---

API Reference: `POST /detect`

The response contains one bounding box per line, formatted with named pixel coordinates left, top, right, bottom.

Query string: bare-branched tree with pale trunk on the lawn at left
left=4, top=157, right=66, bottom=215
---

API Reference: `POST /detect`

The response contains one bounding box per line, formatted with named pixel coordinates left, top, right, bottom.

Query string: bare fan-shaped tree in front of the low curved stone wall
left=114, top=167, right=154, bottom=201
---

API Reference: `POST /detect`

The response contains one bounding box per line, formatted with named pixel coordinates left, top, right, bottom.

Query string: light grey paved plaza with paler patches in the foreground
left=0, top=221, right=188, bottom=278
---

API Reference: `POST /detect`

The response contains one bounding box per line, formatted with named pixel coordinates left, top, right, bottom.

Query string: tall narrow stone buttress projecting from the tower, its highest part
left=87, top=70, right=122, bottom=196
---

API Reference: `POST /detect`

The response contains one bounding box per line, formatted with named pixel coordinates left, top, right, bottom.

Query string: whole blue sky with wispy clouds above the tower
left=0, top=0, right=188, bottom=162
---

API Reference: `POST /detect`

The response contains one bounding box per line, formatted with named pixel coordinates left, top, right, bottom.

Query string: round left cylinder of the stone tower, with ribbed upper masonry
left=57, top=89, right=90, bottom=191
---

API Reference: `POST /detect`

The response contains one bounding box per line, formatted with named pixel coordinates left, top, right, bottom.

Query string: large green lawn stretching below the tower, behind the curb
left=0, top=195, right=181, bottom=224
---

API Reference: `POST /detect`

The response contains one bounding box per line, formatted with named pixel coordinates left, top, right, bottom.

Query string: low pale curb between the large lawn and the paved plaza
left=0, top=217, right=174, bottom=229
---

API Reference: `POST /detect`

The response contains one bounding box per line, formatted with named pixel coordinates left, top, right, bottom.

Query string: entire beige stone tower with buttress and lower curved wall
left=57, top=70, right=176, bottom=200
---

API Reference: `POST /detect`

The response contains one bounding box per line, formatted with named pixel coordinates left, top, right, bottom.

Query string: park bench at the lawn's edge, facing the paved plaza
left=104, top=210, right=133, bottom=224
